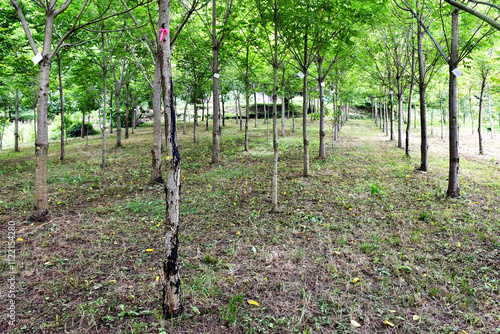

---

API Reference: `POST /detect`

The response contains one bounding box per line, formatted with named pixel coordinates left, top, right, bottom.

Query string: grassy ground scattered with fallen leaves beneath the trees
left=0, top=114, right=500, bottom=334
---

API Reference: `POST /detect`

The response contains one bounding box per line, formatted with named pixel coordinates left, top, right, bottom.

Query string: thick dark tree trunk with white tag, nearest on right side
left=446, top=8, right=460, bottom=197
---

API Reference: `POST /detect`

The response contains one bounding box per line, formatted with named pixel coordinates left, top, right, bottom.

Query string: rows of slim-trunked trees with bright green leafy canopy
left=0, top=0, right=498, bottom=317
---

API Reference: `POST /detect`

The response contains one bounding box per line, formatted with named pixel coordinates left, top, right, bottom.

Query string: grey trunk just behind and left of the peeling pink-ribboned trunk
left=151, top=56, right=163, bottom=183
